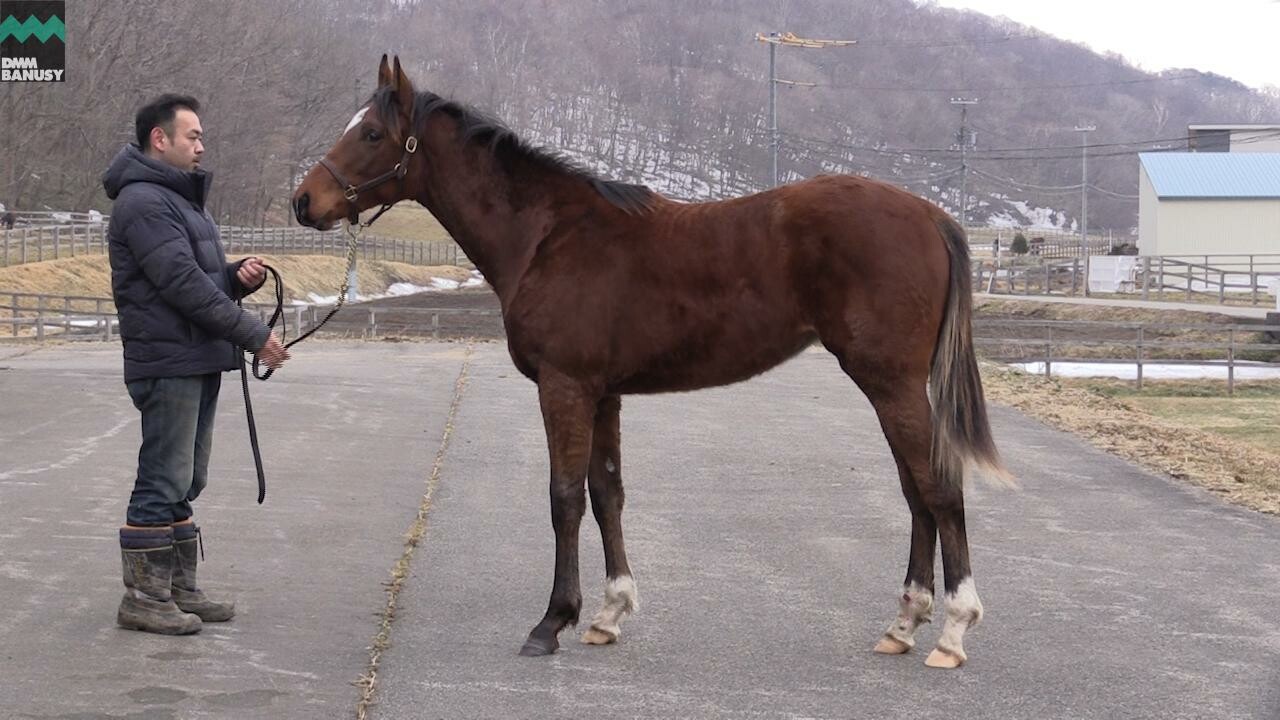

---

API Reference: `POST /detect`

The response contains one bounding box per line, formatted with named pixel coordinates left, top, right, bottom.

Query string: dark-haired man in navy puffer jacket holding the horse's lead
left=102, top=95, right=289, bottom=634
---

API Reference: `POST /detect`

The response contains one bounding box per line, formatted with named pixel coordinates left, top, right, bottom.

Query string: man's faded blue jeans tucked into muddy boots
left=127, top=373, right=223, bottom=527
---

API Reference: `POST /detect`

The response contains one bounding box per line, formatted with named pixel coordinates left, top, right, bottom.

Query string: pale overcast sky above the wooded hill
left=934, top=0, right=1280, bottom=87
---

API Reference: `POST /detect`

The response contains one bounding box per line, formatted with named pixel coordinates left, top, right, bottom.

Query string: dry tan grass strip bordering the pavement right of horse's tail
left=983, top=364, right=1280, bottom=515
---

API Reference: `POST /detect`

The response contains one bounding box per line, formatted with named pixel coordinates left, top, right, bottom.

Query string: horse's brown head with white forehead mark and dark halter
left=293, top=55, right=419, bottom=229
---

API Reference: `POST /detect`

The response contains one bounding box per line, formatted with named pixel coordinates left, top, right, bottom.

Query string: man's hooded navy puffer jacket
left=102, top=145, right=270, bottom=383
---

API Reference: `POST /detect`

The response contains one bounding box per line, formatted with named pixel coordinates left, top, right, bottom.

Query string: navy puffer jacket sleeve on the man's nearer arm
left=123, top=200, right=270, bottom=351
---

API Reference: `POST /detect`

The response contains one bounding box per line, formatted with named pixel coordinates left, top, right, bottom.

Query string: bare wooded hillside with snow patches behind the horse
left=0, top=0, right=1280, bottom=232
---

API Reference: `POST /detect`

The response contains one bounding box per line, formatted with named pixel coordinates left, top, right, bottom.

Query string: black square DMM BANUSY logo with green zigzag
left=0, top=0, right=67, bottom=82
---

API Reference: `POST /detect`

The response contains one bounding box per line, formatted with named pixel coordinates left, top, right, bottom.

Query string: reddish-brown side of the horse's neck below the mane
left=417, top=120, right=552, bottom=306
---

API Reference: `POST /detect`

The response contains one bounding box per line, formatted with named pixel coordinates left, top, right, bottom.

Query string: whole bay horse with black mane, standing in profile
left=292, top=55, right=1004, bottom=667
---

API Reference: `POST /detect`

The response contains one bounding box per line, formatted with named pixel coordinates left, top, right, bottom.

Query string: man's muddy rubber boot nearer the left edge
left=115, top=528, right=201, bottom=635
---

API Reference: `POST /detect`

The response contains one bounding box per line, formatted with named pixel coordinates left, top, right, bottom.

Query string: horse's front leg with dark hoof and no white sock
left=520, top=370, right=599, bottom=656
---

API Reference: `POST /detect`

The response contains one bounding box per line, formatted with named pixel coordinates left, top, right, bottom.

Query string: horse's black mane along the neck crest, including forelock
left=372, top=86, right=657, bottom=214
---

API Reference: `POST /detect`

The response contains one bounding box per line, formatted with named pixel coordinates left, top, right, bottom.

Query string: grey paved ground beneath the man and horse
left=0, top=342, right=1280, bottom=720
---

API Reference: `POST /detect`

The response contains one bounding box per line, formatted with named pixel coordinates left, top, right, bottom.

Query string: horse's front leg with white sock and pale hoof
left=582, top=396, right=639, bottom=644
